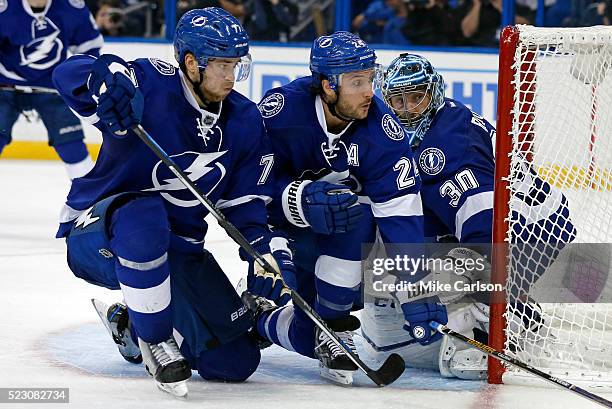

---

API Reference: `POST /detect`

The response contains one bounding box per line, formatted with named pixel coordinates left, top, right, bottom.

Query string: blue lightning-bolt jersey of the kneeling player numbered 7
left=53, top=55, right=274, bottom=252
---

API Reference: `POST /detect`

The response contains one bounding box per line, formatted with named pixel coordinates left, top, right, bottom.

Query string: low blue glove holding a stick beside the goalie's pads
left=401, top=296, right=448, bottom=345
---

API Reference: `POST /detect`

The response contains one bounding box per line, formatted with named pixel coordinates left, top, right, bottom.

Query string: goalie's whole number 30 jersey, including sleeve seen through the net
left=414, top=98, right=576, bottom=247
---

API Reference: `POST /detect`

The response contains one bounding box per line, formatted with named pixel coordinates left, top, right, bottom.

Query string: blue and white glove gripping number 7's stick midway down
left=247, top=237, right=297, bottom=305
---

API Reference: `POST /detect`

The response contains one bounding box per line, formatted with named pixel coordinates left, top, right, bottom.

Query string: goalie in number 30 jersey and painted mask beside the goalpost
left=362, top=54, right=576, bottom=379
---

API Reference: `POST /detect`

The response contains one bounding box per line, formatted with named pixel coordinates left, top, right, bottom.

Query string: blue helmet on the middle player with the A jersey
left=310, top=31, right=382, bottom=89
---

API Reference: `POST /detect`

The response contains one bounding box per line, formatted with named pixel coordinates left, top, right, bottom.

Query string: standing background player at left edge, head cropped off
left=0, top=0, right=103, bottom=179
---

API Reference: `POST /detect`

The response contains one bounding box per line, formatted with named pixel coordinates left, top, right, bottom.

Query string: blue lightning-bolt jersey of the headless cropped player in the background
left=0, top=0, right=103, bottom=88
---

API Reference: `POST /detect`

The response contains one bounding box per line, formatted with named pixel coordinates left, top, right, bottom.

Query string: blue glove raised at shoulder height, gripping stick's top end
left=87, top=54, right=144, bottom=135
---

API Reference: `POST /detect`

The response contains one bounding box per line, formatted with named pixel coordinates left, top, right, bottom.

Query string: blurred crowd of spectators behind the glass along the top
left=88, top=0, right=612, bottom=47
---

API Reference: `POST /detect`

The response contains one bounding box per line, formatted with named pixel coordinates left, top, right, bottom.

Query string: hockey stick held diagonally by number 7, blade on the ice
left=131, top=125, right=405, bottom=386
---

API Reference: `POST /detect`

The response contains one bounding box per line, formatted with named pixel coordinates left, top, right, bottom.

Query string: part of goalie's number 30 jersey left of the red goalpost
left=414, top=98, right=495, bottom=243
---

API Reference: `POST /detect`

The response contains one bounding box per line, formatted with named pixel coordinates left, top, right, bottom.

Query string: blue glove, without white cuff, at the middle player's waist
left=302, top=181, right=363, bottom=234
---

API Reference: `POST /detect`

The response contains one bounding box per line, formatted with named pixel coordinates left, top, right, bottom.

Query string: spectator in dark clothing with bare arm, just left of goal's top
left=458, top=0, right=529, bottom=47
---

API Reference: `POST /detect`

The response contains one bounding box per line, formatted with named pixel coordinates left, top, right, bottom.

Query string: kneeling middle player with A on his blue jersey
left=251, top=32, right=446, bottom=384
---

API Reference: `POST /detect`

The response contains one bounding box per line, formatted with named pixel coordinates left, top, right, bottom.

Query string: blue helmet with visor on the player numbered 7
left=174, top=7, right=251, bottom=81
